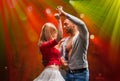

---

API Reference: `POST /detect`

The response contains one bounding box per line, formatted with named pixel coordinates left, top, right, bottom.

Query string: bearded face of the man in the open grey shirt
left=64, top=19, right=73, bottom=33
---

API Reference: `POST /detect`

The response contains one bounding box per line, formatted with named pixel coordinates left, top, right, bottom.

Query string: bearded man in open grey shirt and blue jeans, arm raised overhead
left=57, top=6, right=89, bottom=81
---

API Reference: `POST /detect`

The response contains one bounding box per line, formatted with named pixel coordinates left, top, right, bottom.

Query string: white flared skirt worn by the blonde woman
left=33, top=67, right=65, bottom=81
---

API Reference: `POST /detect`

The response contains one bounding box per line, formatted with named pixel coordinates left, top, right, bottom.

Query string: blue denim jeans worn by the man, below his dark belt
left=65, top=70, right=89, bottom=81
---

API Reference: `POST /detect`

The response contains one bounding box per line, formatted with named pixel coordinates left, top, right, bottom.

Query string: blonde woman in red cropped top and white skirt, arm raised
left=34, top=14, right=64, bottom=81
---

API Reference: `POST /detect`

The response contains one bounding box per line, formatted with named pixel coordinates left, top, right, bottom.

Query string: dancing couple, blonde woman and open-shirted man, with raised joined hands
left=34, top=6, right=89, bottom=81
